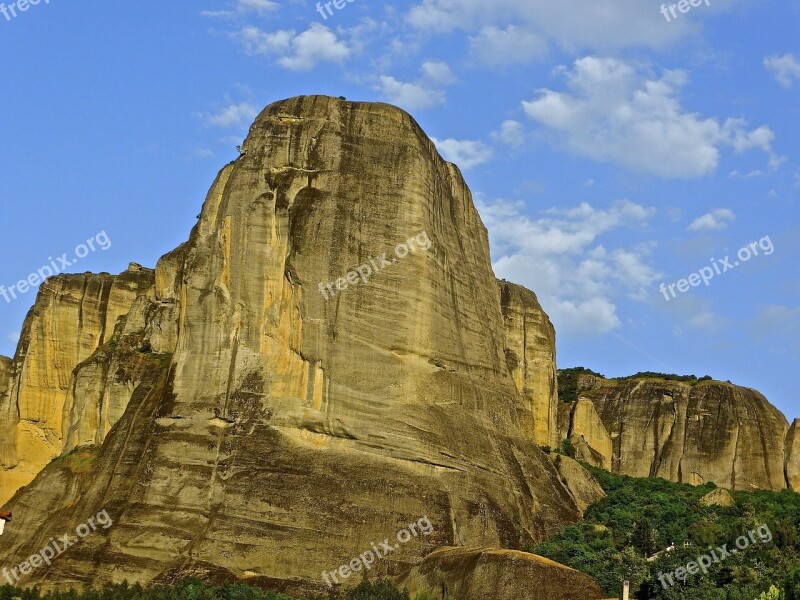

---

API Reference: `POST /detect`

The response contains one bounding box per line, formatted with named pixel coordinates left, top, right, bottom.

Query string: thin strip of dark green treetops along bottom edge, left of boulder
left=0, top=579, right=444, bottom=600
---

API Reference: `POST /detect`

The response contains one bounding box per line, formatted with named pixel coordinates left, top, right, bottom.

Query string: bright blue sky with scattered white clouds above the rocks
left=0, top=0, right=800, bottom=419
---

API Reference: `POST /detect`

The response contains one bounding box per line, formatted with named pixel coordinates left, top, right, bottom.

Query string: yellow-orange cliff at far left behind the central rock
left=0, top=267, right=153, bottom=505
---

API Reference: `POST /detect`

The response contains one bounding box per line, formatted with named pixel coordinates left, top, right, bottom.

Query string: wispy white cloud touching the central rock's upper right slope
left=478, top=198, right=660, bottom=334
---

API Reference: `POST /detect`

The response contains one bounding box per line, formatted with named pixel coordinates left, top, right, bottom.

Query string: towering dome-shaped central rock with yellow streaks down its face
left=0, top=97, right=580, bottom=590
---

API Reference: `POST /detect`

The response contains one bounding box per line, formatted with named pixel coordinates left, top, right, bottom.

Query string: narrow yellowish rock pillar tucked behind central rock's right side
left=498, top=281, right=558, bottom=447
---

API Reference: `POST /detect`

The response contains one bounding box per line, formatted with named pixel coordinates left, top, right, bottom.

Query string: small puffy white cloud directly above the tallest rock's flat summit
left=234, top=23, right=353, bottom=71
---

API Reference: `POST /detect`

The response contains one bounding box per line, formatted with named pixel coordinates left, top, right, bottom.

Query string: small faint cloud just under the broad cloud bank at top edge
left=470, top=25, right=547, bottom=66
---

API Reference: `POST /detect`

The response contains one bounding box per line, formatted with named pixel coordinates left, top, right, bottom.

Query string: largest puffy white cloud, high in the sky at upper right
left=522, top=56, right=774, bottom=178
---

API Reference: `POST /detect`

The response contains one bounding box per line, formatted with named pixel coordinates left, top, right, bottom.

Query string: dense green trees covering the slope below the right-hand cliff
left=527, top=465, right=800, bottom=600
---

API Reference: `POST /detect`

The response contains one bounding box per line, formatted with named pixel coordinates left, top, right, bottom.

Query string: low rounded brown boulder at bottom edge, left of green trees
left=401, top=548, right=605, bottom=600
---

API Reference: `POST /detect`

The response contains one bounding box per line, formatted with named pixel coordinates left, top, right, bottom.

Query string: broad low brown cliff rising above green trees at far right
left=561, top=375, right=799, bottom=490
